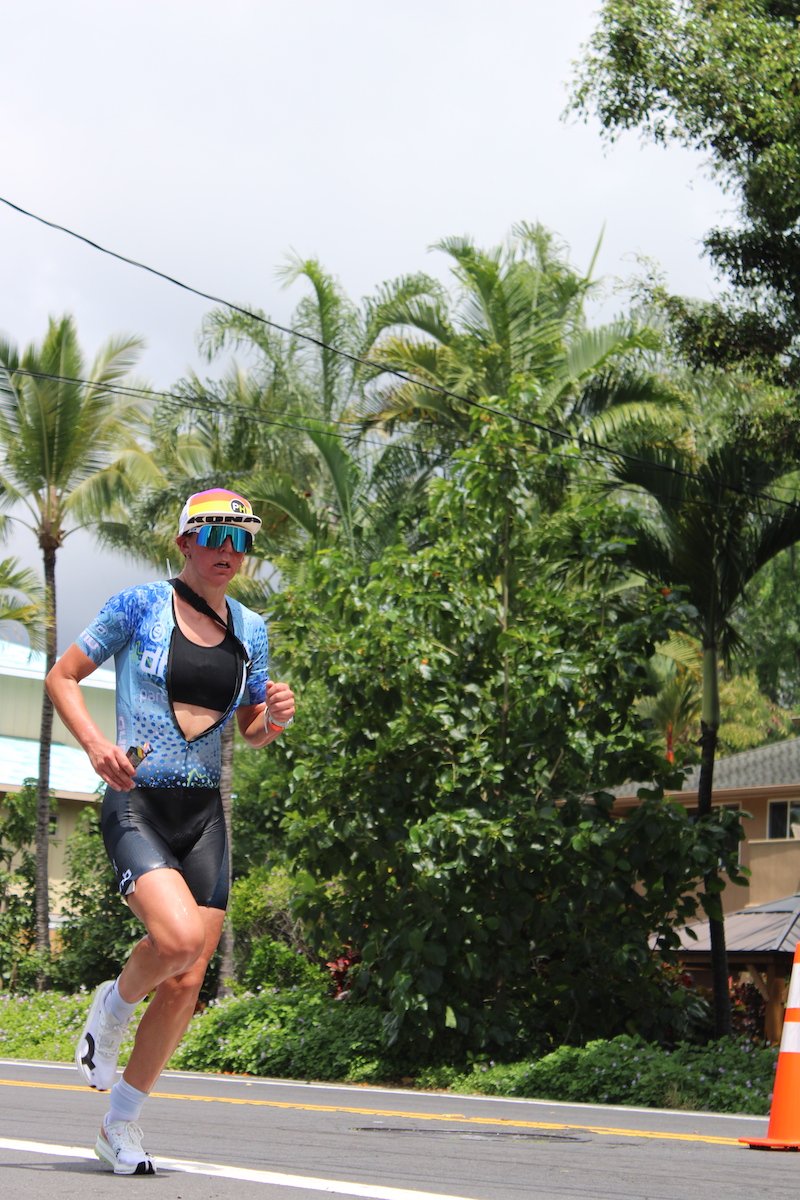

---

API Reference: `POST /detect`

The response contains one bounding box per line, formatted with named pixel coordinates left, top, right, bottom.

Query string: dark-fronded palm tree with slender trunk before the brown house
left=612, top=427, right=800, bottom=1037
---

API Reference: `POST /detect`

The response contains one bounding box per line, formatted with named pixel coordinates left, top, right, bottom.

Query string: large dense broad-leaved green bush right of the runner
left=237, top=422, right=735, bottom=1057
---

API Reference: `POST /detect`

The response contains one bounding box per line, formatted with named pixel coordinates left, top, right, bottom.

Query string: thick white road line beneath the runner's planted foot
left=0, top=1138, right=469, bottom=1200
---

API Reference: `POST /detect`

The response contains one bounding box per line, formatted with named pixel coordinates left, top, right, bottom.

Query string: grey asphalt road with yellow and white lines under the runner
left=0, top=1061, right=800, bottom=1200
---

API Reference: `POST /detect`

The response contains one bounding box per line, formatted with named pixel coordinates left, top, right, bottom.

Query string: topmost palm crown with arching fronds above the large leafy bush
left=361, top=224, right=679, bottom=451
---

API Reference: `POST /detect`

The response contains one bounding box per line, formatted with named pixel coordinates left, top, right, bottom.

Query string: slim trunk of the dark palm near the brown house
left=697, top=643, right=730, bottom=1038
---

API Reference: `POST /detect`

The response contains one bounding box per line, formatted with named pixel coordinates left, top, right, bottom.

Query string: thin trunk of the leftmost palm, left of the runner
left=36, top=547, right=56, bottom=988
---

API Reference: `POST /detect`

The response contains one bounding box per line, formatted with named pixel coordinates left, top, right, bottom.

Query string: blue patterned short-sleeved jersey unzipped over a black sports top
left=76, top=581, right=269, bottom=787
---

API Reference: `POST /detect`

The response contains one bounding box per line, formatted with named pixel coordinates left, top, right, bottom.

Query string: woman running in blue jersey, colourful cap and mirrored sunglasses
left=47, top=488, right=295, bottom=1175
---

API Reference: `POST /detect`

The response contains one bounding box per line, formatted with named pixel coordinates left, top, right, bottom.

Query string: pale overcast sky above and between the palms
left=0, top=0, right=728, bottom=648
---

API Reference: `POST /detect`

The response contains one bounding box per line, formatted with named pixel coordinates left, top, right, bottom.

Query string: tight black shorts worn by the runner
left=101, top=787, right=228, bottom=910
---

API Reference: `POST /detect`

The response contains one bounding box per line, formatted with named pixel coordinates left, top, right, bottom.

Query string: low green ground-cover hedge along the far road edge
left=0, top=988, right=777, bottom=1116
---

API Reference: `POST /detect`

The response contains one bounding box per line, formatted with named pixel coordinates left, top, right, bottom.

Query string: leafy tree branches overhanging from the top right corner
left=575, top=0, right=800, bottom=382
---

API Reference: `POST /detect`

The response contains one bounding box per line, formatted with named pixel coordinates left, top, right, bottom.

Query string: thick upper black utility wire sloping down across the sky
left=0, top=196, right=798, bottom=509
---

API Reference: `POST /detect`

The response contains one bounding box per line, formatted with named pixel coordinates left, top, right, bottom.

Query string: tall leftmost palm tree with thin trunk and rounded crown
left=0, top=317, right=146, bottom=950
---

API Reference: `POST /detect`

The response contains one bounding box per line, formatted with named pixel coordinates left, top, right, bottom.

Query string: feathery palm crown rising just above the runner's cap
left=194, top=256, right=434, bottom=569
